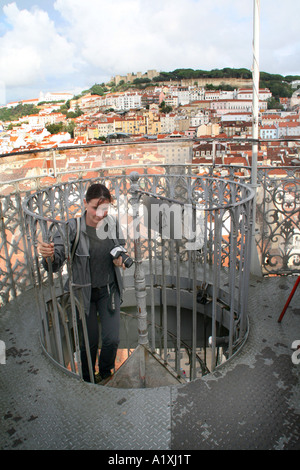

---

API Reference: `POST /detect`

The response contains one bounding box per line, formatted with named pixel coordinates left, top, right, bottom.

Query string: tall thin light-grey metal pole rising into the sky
left=251, top=0, right=261, bottom=276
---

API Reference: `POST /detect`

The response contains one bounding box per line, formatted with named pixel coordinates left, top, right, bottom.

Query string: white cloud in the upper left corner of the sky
left=0, top=3, right=75, bottom=87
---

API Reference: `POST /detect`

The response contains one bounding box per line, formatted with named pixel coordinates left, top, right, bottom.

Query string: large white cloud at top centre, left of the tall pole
left=54, top=0, right=252, bottom=74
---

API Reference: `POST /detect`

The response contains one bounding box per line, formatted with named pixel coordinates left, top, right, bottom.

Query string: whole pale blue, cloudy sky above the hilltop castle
left=0, top=0, right=300, bottom=104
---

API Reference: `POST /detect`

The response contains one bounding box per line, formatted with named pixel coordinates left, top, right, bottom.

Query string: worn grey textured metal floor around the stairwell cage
left=0, top=277, right=300, bottom=451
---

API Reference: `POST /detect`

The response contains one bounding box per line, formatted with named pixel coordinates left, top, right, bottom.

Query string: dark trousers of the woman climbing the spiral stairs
left=81, top=284, right=120, bottom=382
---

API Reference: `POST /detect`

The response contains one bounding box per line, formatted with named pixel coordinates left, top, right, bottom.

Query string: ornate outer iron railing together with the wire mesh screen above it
left=0, top=140, right=300, bottom=294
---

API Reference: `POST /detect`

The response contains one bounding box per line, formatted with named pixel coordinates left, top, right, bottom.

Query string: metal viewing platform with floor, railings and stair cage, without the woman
left=0, top=149, right=300, bottom=450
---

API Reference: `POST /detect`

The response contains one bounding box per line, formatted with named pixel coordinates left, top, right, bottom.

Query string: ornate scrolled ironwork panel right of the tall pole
left=256, top=168, right=300, bottom=274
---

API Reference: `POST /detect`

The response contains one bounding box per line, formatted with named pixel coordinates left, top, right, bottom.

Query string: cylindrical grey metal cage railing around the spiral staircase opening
left=23, top=173, right=254, bottom=379
